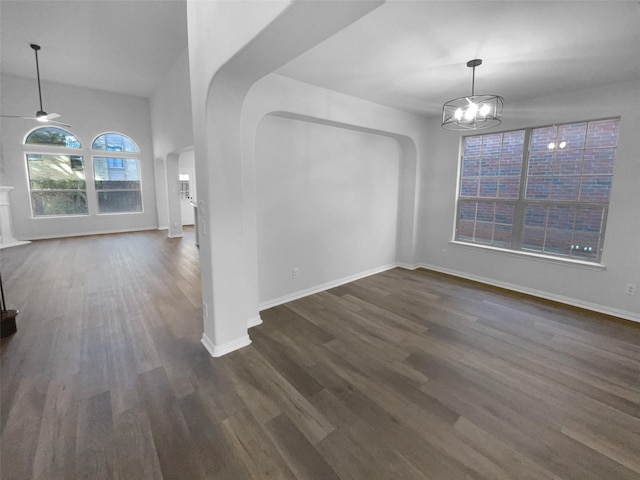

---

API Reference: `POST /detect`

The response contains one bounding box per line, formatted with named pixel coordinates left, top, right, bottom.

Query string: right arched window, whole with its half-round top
left=91, top=133, right=142, bottom=213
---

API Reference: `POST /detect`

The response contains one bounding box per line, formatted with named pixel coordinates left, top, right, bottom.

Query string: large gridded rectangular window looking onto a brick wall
left=455, top=118, right=619, bottom=262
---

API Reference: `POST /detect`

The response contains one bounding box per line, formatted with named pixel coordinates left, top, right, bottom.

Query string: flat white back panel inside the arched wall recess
left=255, top=115, right=401, bottom=304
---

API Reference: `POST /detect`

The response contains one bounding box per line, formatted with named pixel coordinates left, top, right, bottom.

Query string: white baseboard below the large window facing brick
left=418, top=264, right=640, bottom=323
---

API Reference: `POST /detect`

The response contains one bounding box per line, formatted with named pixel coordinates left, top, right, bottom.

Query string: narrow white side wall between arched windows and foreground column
left=150, top=49, right=193, bottom=235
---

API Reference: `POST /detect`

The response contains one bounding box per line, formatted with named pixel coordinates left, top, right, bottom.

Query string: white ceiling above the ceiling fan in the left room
left=0, top=0, right=187, bottom=97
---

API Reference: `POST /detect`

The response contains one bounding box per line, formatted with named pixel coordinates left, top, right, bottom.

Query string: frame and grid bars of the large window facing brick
left=452, top=116, right=621, bottom=268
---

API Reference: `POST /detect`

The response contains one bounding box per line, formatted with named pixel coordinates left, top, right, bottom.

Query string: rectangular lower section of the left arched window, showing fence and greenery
left=27, top=153, right=89, bottom=217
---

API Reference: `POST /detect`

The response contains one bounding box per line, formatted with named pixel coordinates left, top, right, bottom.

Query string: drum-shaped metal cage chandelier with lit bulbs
left=442, top=58, right=504, bottom=130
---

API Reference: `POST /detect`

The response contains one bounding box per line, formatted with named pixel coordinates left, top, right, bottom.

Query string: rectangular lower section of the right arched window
left=93, top=157, right=142, bottom=213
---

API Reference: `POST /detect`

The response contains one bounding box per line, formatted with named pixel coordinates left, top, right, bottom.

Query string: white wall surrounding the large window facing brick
left=418, top=83, right=640, bottom=321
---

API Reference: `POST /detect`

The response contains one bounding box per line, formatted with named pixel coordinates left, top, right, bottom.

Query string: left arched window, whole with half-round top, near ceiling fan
left=24, top=127, right=89, bottom=217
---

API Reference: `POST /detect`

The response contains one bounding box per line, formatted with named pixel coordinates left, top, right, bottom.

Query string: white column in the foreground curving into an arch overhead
left=187, top=1, right=383, bottom=357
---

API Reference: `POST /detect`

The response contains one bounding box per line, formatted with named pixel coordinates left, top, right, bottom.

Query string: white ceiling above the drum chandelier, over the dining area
left=278, top=1, right=640, bottom=115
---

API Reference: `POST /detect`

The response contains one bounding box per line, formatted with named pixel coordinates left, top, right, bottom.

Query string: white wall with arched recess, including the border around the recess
left=242, top=74, right=429, bottom=309
